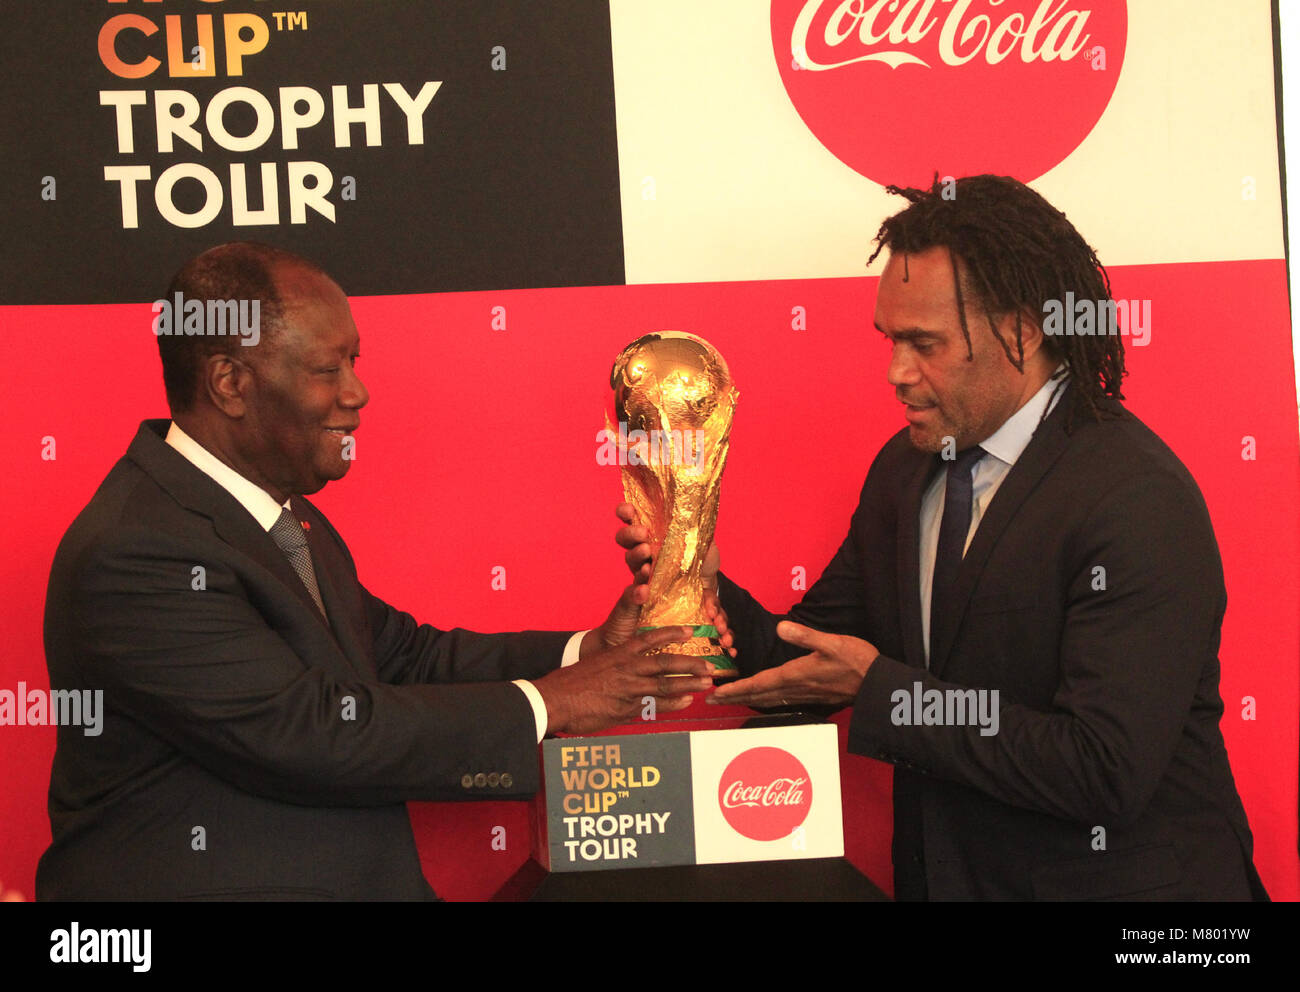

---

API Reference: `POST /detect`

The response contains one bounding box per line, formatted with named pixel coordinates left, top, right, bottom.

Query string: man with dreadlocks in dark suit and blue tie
left=619, top=176, right=1268, bottom=900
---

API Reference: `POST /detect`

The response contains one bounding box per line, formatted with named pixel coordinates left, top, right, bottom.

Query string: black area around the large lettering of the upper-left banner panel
left=0, top=0, right=624, bottom=304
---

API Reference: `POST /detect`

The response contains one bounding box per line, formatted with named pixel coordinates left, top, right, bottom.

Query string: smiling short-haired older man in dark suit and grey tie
left=36, top=244, right=711, bottom=900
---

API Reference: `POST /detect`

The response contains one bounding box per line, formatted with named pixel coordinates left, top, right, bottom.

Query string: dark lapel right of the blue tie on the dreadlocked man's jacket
left=930, top=387, right=1074, bottom=677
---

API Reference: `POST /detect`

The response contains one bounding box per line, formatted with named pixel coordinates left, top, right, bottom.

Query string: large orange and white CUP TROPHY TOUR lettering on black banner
left=98, top=0, right=442, bottom=229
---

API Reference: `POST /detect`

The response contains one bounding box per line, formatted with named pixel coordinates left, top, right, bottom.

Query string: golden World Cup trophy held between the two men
left=607, top=330, right=738, bottom=677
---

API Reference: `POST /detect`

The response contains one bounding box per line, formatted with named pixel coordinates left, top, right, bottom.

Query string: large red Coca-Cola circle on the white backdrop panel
left=771, top=0, right=1128, bottom=186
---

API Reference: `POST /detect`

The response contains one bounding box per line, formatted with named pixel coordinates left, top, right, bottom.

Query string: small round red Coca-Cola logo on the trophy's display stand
left=718, top=748, right=813, bottom=840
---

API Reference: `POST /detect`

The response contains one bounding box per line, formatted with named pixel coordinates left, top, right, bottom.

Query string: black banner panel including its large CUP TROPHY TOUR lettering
left=0, top=0, right=624, bottom=303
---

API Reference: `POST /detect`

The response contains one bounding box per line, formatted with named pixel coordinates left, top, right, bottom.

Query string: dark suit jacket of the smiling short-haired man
left=36, top=420, right=568, bottom=900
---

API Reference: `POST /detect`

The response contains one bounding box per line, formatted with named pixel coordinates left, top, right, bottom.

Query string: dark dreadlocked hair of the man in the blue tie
left=867, top=172, right=1127, bottom=430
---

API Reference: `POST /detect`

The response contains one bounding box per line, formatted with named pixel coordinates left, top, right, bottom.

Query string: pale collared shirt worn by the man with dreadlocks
left=920, top=364, right=1065, bottom=667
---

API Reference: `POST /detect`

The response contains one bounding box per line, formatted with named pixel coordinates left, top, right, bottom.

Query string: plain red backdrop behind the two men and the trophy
left=0, top=260, right=1300, bottom=900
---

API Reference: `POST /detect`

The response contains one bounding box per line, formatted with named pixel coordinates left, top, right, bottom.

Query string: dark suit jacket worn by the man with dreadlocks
left=722, top=389, right=1264, bottom=900
